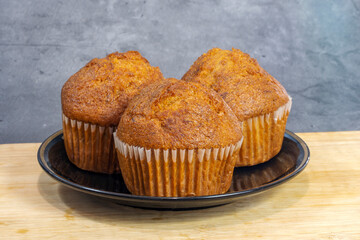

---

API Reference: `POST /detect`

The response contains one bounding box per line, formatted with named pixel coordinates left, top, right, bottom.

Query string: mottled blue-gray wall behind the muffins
left=0, top=0, right=360, bottom=143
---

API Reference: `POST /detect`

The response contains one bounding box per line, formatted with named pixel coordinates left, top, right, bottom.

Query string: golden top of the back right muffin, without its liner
left=182, top=48, right=289, bottom=121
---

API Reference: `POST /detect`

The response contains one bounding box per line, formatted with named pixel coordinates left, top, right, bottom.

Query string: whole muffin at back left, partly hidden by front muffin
left=61, top=51, right=163, bottom=174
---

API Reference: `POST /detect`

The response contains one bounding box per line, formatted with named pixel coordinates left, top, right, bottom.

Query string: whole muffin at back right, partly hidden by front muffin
left=182, top=48, right=291, bottom=167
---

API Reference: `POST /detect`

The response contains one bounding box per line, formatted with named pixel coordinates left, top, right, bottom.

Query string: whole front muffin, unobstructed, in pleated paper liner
left=114, top=79, right=242, bottom=197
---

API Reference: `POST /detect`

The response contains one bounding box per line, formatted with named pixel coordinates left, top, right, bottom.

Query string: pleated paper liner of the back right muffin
left=235, top=97, right=292, bottom=167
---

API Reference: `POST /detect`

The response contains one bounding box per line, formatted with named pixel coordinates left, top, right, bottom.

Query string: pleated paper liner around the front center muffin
left=114, top=133, right=242, bottom=197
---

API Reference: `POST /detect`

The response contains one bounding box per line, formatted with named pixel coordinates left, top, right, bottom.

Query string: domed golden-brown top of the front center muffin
left=116, top=79, right=242, bottom=149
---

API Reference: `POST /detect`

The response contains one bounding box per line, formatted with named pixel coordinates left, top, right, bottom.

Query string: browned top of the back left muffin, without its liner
left=61, top=51, right=164, bottom=126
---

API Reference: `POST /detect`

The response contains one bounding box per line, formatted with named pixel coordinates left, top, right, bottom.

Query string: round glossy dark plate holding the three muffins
left=38, top=130, right=310, bottom=210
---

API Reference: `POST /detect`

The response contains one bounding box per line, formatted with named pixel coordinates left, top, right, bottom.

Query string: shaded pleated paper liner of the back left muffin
left=62, top=114, right=120, bottom=174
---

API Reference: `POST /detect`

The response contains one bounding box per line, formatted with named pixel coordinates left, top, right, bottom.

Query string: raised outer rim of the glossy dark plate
left=37, top=129, right=310, bottom=203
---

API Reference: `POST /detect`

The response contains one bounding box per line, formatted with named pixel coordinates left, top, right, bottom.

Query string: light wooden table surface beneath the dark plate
left=0, top=131, right=360, bottom=239
